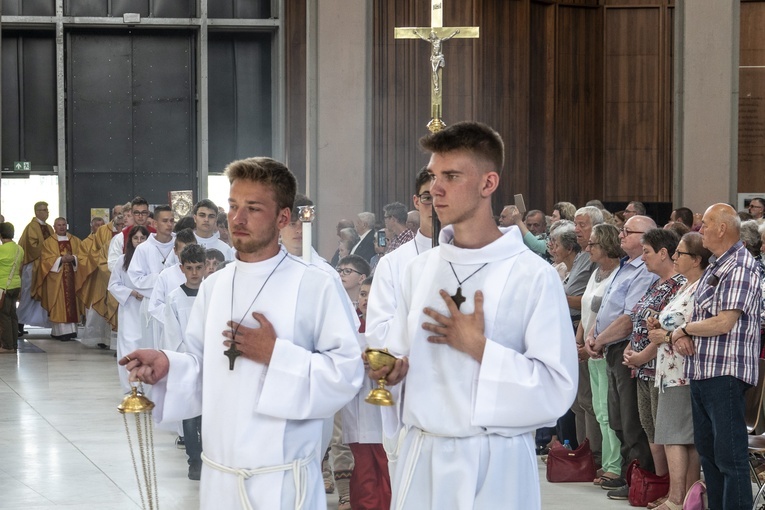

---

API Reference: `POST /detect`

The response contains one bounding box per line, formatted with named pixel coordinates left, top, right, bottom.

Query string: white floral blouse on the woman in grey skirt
left=656, top=280, right=699, bottom=391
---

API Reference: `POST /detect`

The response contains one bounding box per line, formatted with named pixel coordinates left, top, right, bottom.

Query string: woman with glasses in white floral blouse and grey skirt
left=648, top=232, right=712, bottom=510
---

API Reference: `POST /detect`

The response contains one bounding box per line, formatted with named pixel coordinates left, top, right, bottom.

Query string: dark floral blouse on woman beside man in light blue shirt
left=630, top=274, right=686, bottom=381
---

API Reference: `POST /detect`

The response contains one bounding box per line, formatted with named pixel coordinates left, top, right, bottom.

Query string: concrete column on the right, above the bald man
left=673, top=0, right=740, bottom=212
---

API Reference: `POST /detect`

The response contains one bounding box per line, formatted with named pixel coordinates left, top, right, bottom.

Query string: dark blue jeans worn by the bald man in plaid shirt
left=691, top=376, right=752, bottom=510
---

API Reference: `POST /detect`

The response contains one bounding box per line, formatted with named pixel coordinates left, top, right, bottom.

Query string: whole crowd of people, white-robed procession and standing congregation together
left=0, top=122, right=765, bottom=510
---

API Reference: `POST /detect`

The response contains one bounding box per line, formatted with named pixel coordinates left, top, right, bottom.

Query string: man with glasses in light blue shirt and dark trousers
left=585, top=213, right=658, bottom=499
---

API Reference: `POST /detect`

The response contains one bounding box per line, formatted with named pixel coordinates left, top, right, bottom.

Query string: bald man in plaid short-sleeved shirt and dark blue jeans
left=672, top=204, right=762, bottom=510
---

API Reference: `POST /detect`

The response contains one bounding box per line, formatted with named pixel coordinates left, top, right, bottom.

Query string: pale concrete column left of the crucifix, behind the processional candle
left=307, top=0, right=370, bottom=258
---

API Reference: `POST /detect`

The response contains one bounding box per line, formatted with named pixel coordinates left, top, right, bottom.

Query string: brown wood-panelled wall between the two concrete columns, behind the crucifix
left=372, top=0, right=674, bottom=213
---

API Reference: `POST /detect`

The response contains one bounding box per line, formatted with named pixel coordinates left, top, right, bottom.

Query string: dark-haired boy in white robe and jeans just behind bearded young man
left=160, top=243, right=205, bottom=480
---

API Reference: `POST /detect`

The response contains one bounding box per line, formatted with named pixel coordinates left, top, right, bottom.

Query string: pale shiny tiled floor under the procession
left=0, top=328, right=628, bottom=510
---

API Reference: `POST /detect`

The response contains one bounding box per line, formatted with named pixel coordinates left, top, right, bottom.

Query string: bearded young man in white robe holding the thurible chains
left=119, top=158, right=363, bottom=509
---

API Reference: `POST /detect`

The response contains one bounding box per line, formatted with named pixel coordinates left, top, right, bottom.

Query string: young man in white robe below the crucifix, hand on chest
left=370, top=122, right=578, bottom=510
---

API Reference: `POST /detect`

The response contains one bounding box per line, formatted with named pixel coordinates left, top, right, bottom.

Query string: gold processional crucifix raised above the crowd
left=395, top=0, right=479, bottom=134
